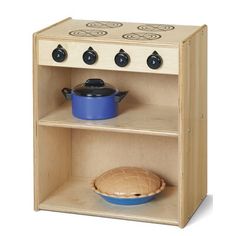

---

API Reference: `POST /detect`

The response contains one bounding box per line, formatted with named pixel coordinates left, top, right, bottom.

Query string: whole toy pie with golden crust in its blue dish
left=92, top=167, right=166, bottom=205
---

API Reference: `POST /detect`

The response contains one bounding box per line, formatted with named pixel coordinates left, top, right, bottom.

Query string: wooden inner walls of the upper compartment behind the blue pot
left=38, top=66, right=178, bottom=119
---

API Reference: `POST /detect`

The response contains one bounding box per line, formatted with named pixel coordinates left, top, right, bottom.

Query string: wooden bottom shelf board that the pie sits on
left=39, top=178, right=178, bottom=225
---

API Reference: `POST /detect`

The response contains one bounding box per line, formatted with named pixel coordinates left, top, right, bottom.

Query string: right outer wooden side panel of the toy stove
left=179, top=26, right=207, bottom=227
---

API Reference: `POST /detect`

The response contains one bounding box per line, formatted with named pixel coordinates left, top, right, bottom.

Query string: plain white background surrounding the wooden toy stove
left=0, top=0, right=233, bottom=236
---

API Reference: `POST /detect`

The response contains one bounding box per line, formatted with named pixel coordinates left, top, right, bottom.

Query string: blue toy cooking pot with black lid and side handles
left=62, top=79, right=128, bottom=120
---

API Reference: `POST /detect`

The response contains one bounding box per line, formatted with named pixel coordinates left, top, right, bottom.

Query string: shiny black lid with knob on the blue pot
left=73, top=79, right=117, bottom=97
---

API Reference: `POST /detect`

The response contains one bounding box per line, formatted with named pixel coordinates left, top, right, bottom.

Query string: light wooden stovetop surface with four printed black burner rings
left=38, top=18, right=203, bottom=45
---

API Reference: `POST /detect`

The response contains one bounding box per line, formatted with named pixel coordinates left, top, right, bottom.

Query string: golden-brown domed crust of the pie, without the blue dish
left=94, top=167, right=165, bottom=198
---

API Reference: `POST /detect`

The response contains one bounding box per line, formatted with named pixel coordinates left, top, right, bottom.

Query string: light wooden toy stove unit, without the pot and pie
left=33, top=18, right=207, bottom=227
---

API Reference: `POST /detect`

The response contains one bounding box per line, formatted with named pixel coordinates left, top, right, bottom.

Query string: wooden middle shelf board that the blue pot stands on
left=39, top=102, right=178, bottom=137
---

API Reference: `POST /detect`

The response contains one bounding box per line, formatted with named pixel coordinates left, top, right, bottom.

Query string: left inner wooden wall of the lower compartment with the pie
left=37, top=126, right=71, bottom=203
